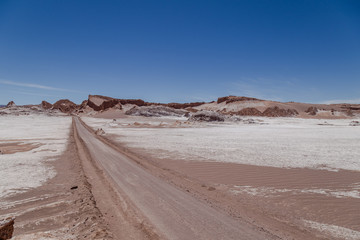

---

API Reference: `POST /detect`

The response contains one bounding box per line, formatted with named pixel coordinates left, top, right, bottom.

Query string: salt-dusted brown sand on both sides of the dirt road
left=0, top=112, right=360, bottom=239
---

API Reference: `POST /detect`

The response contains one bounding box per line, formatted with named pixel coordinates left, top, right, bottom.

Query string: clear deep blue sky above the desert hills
left=0, top=0, right=360, bottom=104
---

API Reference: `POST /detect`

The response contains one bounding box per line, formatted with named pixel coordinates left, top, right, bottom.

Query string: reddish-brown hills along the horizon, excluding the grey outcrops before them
left=41, top=95, right=360, bottom=118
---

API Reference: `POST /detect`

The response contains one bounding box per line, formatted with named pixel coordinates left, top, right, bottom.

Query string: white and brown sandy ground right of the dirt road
left=84, top=117, right=360, bottom=239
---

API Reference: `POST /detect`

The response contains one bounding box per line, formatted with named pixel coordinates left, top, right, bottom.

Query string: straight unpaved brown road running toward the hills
left=75, top=118, right=272, bottom=239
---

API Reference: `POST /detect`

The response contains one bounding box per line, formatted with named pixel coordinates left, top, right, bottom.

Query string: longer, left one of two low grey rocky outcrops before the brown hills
left=125, top=105, right=188, bottom=117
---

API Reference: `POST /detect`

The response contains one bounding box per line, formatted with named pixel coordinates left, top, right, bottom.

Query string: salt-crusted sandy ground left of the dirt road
left=0, top=116, right=111, bottom=240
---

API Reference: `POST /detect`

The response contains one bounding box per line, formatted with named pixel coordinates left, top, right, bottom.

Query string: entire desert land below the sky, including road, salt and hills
left=0, top=95, right=360, bottom=239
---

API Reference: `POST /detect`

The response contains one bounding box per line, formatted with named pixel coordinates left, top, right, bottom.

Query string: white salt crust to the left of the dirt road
left=0, top=115, right=71, bottom=197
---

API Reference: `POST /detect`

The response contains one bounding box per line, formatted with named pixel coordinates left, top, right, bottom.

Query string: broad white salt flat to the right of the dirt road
left=84, top=118, right=360, bottom=171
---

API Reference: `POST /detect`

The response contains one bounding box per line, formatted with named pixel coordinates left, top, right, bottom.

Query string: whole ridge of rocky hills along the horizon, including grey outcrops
left=3, top=95, right=360, bottom=119
